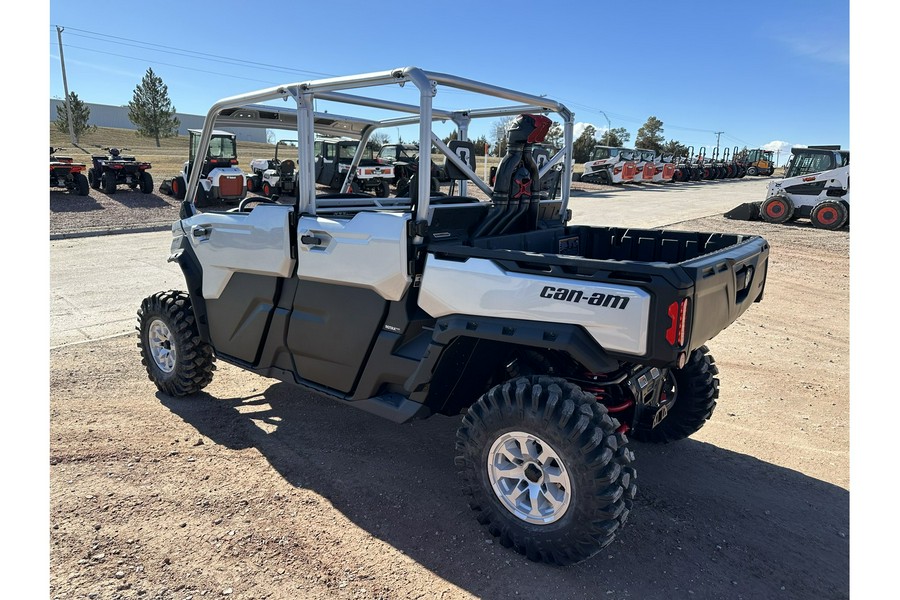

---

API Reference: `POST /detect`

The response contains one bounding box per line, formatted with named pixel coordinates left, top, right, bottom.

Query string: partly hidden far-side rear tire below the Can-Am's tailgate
left=631, top=346, right=719, bottom=444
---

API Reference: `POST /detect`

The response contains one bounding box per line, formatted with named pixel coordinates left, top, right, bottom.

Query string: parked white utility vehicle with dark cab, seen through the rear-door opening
left=315, top=137, right=394, bottom=198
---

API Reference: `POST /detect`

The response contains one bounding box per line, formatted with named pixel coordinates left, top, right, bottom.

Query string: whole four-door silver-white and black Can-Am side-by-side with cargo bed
left=137, top=67, right=769, bottom=564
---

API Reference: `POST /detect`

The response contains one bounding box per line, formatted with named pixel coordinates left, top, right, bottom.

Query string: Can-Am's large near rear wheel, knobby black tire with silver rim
left=456, top=375, right=637, bottom=565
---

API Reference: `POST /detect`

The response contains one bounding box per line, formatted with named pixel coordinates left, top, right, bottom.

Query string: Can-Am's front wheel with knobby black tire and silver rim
left=137, top=290, right=216, bottom=396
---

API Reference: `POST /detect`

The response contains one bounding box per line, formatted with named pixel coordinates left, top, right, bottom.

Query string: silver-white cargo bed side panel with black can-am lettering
left=419, top=255, right=650, bottom=354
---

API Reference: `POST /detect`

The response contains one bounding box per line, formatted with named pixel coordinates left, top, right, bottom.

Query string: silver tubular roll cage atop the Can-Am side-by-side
left=184, top=67, right=574, bottom=221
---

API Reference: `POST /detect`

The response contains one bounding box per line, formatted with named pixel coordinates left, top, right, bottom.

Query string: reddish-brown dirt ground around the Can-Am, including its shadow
left=48, top=185, right=850, bottom=600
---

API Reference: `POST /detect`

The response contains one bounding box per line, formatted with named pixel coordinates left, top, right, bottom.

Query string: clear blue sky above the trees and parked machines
left=45, top=0, right=850, bottom=162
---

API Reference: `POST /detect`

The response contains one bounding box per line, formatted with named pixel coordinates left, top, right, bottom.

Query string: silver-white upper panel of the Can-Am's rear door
left=298, top=211, right=411, bottom=300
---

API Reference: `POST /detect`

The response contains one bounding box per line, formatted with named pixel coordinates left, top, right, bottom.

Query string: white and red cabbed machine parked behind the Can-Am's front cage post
left=159, top=129, right=247, bottom=206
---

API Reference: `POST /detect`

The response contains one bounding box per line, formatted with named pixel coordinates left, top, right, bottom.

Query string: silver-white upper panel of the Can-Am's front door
left=182, top=204, right=294, bottom=300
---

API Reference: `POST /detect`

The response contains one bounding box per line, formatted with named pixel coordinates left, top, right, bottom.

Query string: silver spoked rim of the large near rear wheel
left=487, top=431, right=572, bottom=525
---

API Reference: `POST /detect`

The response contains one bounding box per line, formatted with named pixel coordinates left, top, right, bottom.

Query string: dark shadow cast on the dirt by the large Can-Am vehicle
left=158, top=383, right=849, bottom=600
